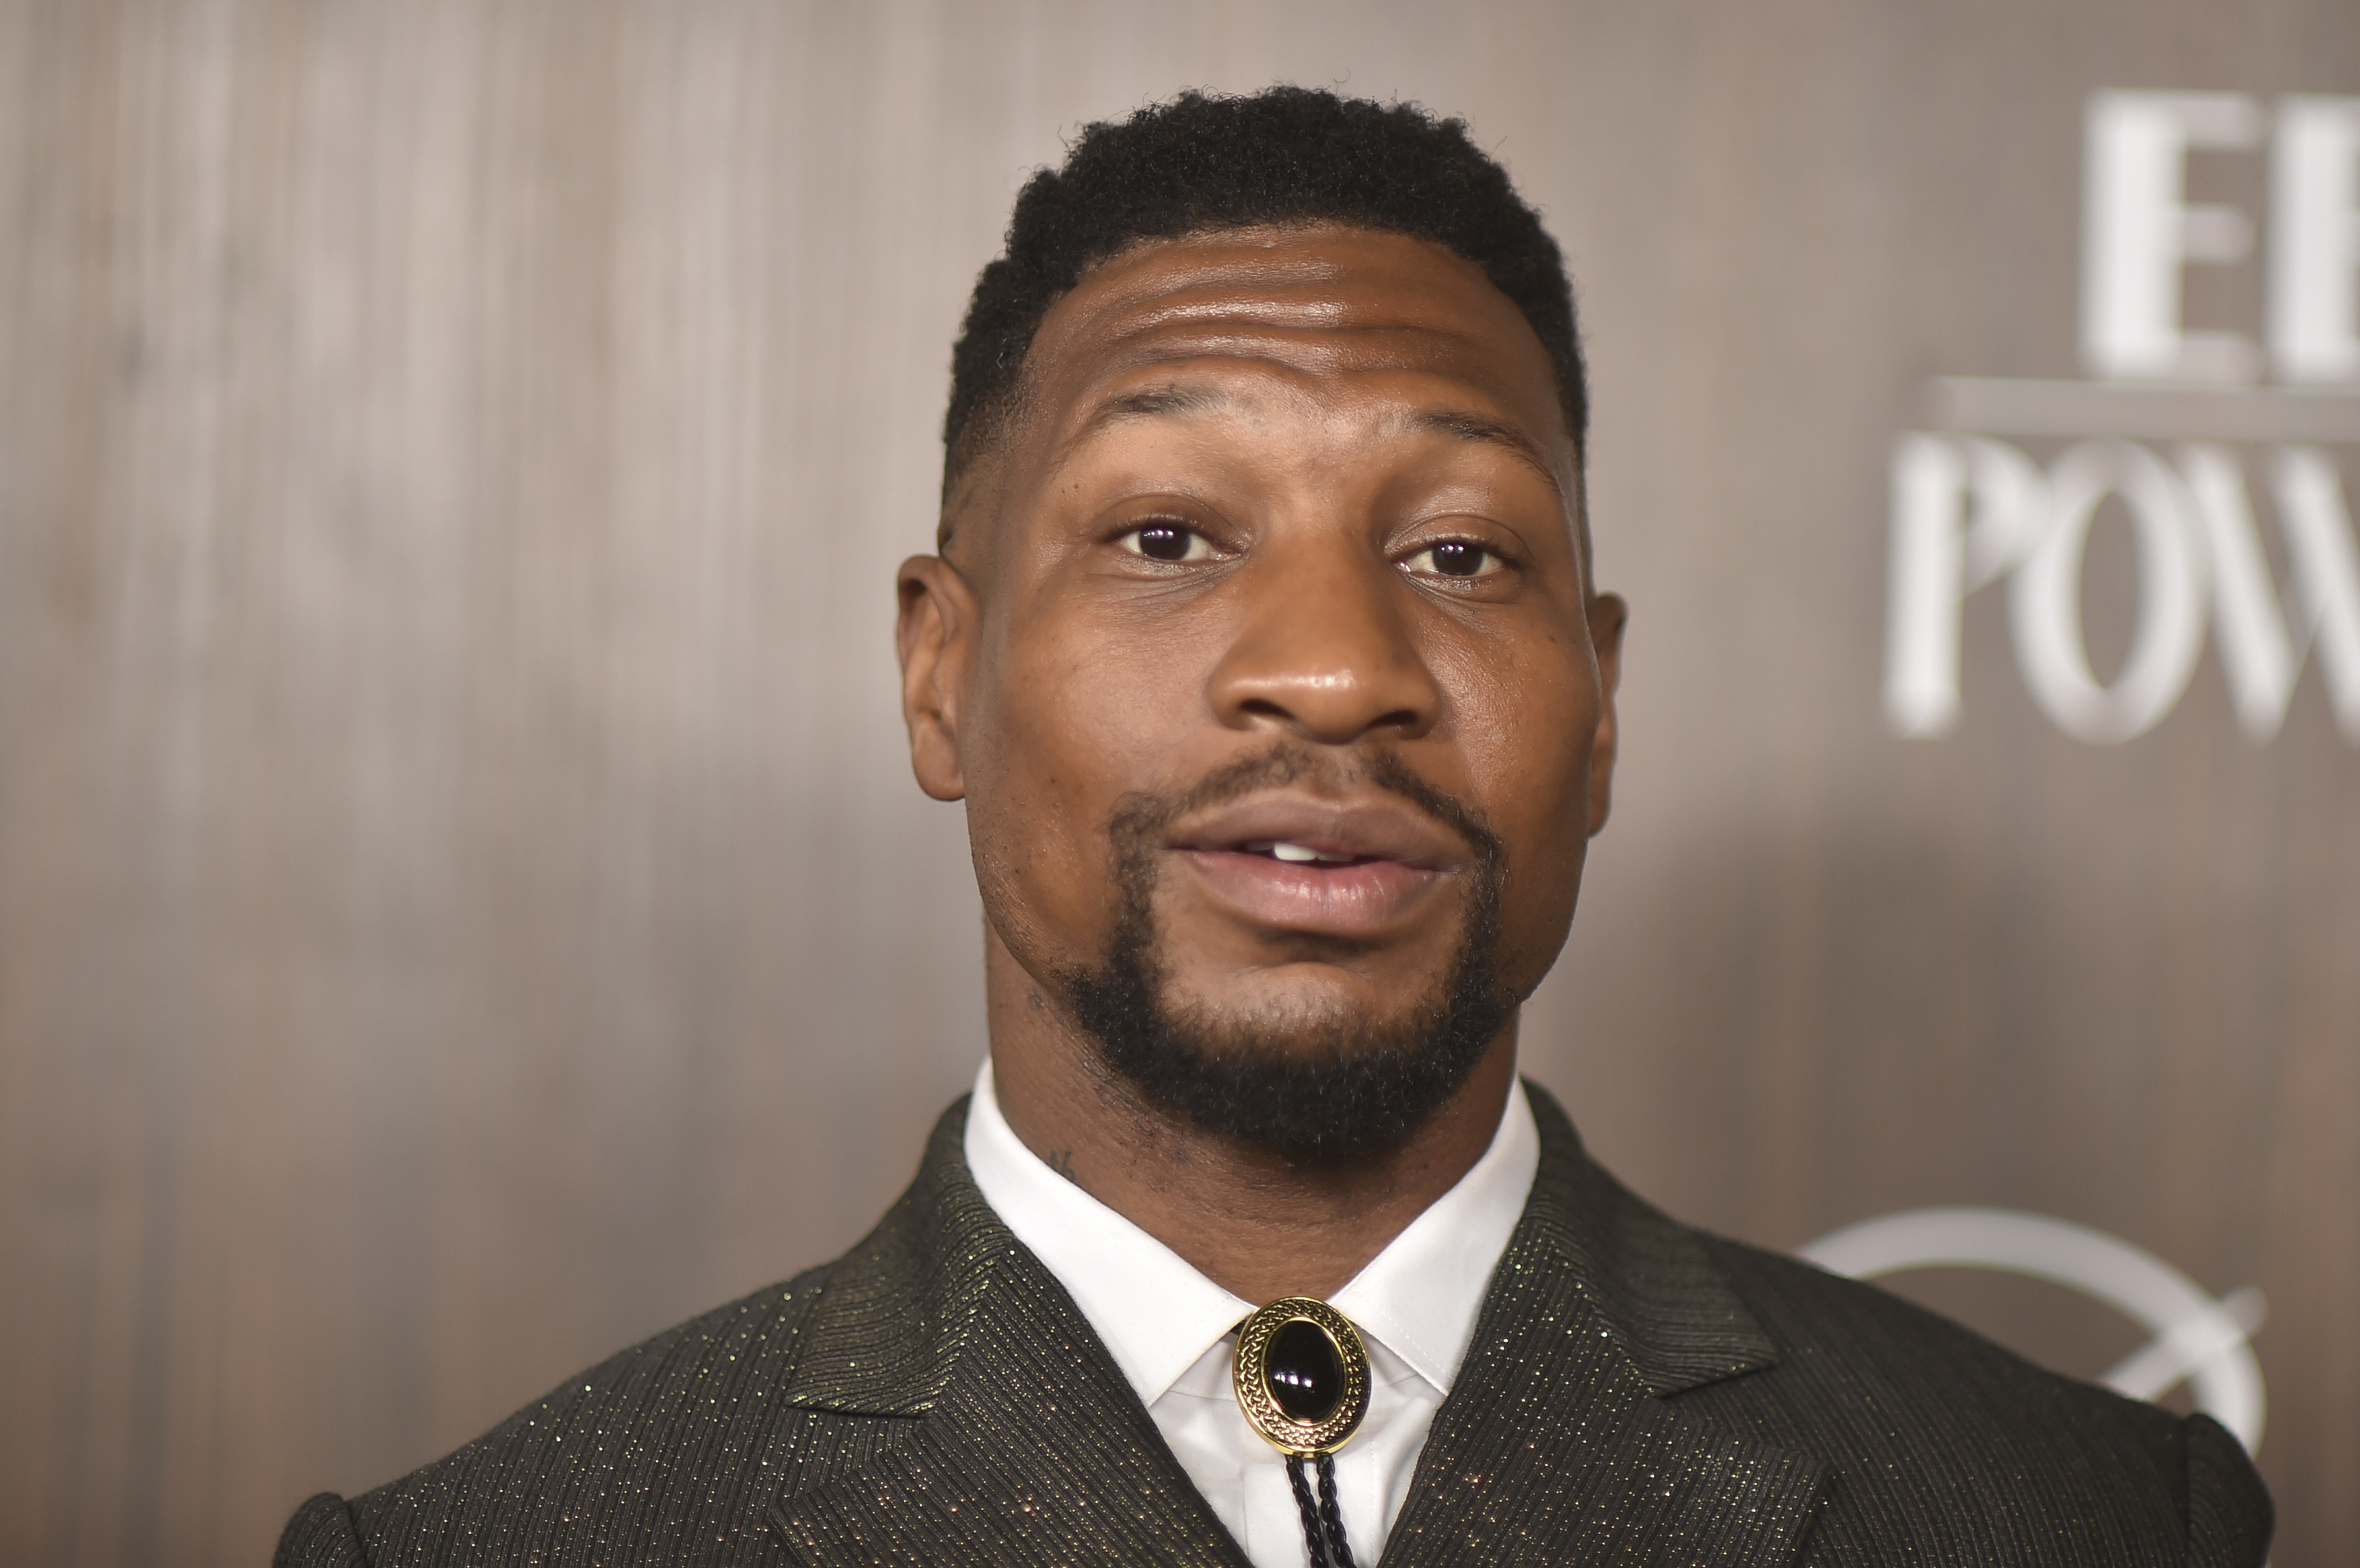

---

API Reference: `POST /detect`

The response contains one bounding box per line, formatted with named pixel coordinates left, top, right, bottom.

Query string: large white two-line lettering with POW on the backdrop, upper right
left=1884, top=92, right=2360, bottom=745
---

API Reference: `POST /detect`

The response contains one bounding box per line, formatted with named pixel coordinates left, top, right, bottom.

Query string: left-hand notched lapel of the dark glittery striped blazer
left=769, top=1101, right=1246, bottom=1568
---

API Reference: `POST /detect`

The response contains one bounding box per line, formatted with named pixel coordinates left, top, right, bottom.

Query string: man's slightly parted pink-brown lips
left=1173, top=794, right=1465, bottom=938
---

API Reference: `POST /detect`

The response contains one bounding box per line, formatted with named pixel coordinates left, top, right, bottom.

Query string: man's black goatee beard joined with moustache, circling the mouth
left=1062, top=748, right=1518, bottom=1162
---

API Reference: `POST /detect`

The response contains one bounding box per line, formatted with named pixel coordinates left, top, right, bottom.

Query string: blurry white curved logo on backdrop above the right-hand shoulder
left=1799, top=1208, right=2265, bottom=1452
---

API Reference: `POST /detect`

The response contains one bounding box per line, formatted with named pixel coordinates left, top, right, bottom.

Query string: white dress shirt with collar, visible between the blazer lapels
left=965, top=1061, right=1541, bottom=1568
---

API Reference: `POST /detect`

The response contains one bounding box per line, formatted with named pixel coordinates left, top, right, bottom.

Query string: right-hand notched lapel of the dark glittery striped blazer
left=1383, top=1087, right=1829, bottom=1568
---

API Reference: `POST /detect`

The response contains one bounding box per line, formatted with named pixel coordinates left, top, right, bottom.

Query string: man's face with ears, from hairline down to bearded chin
left=901, top=226, right=1621, bottom=1141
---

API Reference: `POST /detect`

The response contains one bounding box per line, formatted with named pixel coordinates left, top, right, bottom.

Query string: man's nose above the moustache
left=1208, top=540, right=1442, bottom=745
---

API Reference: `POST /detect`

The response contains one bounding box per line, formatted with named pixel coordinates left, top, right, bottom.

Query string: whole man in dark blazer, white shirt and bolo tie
left=278, top=90, right=2270, bottom=1568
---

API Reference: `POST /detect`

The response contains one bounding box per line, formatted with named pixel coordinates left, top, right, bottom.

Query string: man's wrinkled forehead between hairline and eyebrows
left=1010, top=226, right=1574, bottom=474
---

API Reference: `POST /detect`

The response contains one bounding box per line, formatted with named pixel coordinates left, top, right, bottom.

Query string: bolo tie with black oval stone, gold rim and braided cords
left=1230, top=1297, right=1369, bottom=1568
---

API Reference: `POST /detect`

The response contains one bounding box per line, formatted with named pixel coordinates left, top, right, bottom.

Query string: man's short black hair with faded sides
left=942, top=87, right=1588, bottom=500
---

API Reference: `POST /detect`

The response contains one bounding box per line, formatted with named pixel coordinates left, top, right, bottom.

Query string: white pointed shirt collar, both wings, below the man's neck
left=965, top=1059, right=1541, bottom=1406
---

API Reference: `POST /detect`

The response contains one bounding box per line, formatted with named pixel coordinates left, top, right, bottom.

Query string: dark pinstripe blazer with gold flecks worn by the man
left=276, top=1090, right=2270, bottom=1568
